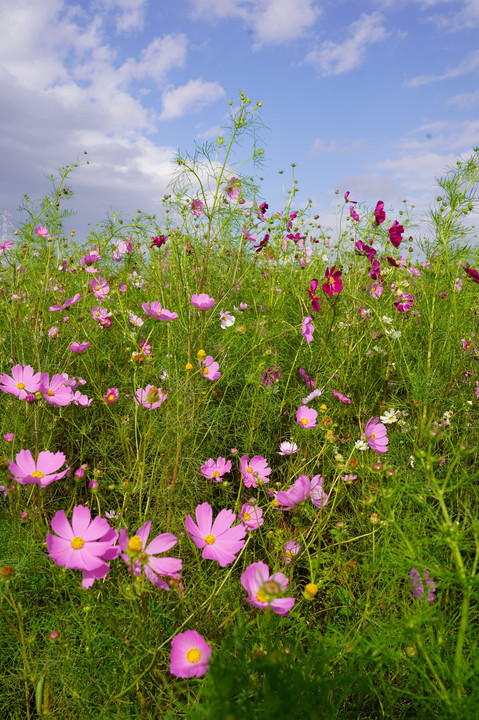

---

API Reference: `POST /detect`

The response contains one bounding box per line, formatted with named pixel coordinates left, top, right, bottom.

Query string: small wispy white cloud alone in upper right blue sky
left=305, top=12, right=389, bottom=76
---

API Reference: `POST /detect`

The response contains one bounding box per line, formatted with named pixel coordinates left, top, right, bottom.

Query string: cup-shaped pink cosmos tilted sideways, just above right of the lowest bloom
left=241, top=562, right=295, bottom=616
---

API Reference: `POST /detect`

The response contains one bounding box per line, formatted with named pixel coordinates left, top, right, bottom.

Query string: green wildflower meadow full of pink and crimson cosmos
left=0, top=94, right=479, bottom=720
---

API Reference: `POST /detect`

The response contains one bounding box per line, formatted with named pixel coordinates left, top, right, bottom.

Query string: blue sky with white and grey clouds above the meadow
left=0, top=0, right=479, bottom=239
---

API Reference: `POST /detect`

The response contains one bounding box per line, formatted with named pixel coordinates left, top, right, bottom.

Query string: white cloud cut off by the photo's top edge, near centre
left=192, top=0, right=320, bottom=48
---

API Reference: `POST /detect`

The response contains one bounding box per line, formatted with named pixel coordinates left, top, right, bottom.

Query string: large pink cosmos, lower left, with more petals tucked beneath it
left=47, top=505, right=120, bottom=589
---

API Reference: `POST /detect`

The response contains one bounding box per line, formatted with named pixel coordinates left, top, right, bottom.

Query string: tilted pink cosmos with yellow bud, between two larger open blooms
left=119, top=520, right=183, bottom=590
